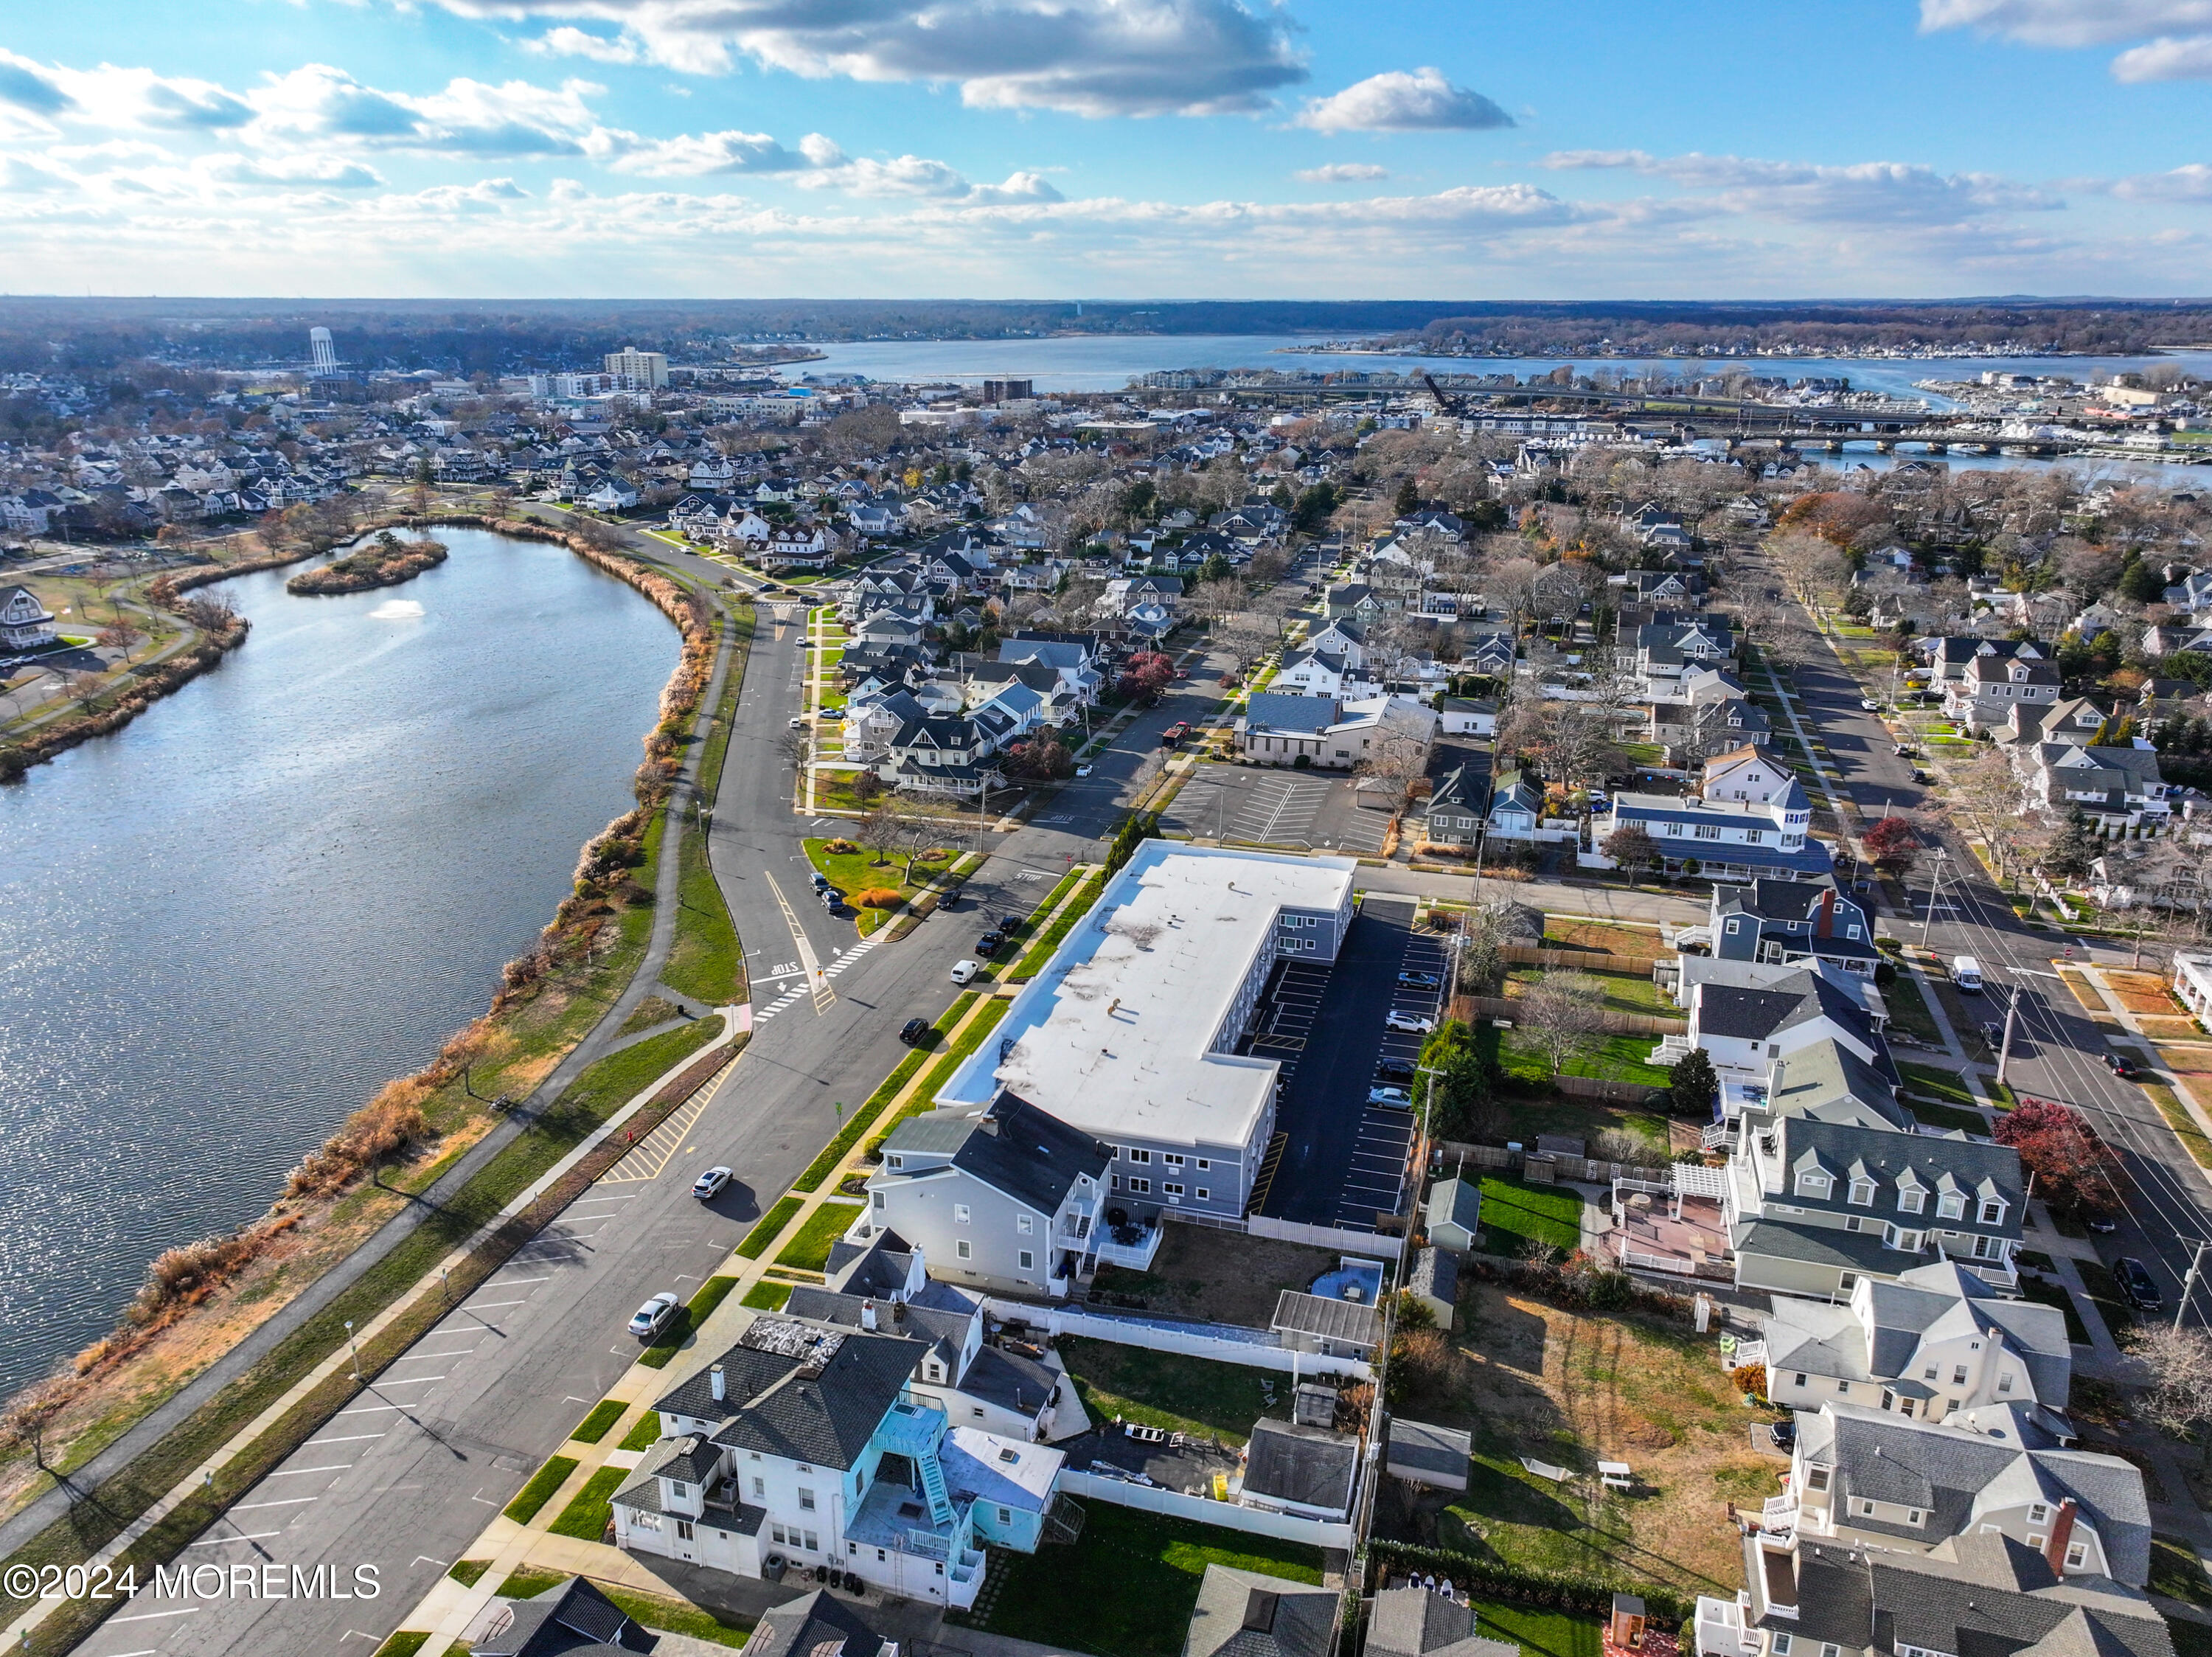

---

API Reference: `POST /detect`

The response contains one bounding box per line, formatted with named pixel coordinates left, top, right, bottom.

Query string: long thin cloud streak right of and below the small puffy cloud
left=1540, top=150, right=2066, bottom=226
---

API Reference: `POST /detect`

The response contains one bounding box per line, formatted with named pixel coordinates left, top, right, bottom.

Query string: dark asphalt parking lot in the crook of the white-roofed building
left=1250, top=894, right=1447, bottom=1232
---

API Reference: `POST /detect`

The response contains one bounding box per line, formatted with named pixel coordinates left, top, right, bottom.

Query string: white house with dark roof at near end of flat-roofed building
left=865, top=1088, right=1113, bottom=1299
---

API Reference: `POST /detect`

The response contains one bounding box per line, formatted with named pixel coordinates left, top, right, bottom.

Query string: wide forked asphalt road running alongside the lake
left=69, top=542, right=1248, bottom=1657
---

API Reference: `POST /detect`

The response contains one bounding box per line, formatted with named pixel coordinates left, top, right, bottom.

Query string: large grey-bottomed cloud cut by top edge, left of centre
left=418, top=0, right=1305, bottom=115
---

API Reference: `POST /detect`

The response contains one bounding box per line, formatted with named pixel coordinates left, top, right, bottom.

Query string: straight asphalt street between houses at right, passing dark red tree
left=1794, top=628, right=2212, bottom=1316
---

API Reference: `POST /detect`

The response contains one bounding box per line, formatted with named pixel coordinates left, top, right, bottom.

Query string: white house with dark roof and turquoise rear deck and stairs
left=613, top=1316, right=1062, bottom=1608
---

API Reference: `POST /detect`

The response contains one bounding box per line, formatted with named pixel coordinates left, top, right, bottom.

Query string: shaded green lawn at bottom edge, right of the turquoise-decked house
left=960, top=1502, right=1321, bottom=1657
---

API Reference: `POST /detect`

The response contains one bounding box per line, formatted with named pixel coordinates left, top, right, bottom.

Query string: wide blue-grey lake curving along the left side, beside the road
left=0, top=529, right=679, bottom=1392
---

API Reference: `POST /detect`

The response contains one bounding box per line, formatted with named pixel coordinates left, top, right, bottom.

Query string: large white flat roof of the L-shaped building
left=938, top=841, right=1358, bottom=1148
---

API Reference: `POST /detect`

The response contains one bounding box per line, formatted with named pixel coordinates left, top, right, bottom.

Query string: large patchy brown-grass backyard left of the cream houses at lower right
left=1407, top=1283, right=1785, bottom=1593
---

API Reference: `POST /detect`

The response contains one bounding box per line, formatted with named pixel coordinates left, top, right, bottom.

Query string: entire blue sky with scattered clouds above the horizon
left=0, top=0, right=2212, bottom=299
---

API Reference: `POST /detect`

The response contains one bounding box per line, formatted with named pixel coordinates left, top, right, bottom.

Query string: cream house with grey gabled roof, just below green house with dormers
left=1759, top=1261, right=2073, bottom=1442
